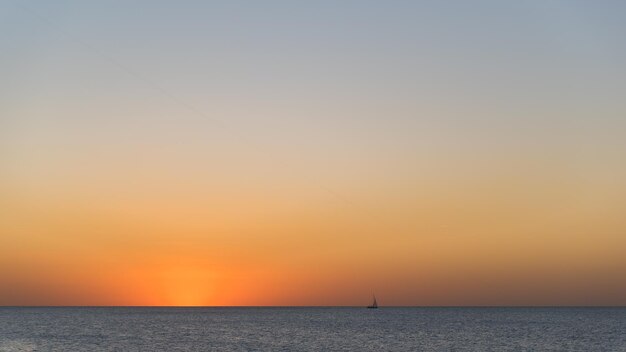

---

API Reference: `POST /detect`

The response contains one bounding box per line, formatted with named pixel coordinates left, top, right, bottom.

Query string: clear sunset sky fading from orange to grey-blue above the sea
left=0, top=0, right=626, bottom=306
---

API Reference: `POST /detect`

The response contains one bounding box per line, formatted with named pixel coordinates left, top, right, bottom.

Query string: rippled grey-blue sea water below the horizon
left=0, top=307, right=626, bottom=352
